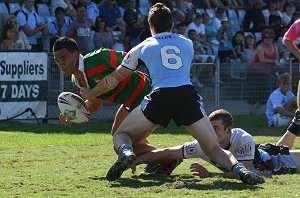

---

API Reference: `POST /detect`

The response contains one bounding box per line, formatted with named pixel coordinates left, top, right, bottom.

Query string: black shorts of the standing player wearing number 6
left=141, top=85, right=206, bottom=127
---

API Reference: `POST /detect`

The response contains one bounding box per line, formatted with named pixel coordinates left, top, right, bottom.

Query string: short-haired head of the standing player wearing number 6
left=148, top=3, right=173, bottom=33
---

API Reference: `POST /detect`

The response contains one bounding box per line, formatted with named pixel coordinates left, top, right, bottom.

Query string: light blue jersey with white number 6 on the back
left=122, top=32, right=194, bottom=90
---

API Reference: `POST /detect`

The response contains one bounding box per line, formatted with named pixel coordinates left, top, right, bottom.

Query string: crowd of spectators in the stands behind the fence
left=0, top=0, right=300, bottom=56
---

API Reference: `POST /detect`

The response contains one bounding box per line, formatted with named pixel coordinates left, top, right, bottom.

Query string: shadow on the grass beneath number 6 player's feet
left=91, top=175, right=263, bottom=190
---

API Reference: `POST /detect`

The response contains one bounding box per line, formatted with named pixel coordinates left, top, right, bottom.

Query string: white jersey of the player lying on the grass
left=183, top=128, right=256, bottom=167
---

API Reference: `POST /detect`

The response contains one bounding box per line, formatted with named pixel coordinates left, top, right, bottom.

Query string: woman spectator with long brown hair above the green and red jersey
left=93, top=17, right=114, bottom=49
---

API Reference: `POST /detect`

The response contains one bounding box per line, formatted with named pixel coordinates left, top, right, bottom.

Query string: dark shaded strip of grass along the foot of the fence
left=0, top=115, right=286, bottom=137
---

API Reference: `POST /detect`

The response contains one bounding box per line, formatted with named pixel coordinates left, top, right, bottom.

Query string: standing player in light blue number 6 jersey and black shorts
left=82, top=3, right=264, bottom=184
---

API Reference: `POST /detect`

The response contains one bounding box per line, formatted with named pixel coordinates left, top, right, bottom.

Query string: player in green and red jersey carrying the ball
left=53, top=37, right=178, bottom=171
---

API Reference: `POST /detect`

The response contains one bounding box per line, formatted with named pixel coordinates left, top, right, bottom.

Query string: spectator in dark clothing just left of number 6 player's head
left=123, top=0, right=151, bottom=48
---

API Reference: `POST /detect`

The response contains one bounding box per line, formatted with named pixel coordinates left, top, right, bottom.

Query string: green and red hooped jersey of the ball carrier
left=79, top=48, right=151, bottom=110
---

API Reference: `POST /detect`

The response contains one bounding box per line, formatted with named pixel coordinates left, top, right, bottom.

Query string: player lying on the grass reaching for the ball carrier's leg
left=137, top=109, right=300, bottom=177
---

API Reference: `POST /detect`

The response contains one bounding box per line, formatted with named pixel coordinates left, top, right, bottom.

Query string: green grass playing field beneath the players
left=0, top=115, right=300, bottom=198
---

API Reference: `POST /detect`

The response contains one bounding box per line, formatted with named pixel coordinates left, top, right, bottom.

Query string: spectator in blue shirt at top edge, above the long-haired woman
left=99, top=0, right=126, bottom=32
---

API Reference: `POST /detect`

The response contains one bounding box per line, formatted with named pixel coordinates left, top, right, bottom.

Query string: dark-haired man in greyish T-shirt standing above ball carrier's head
left=66, top=4, right=91, bottom=55
